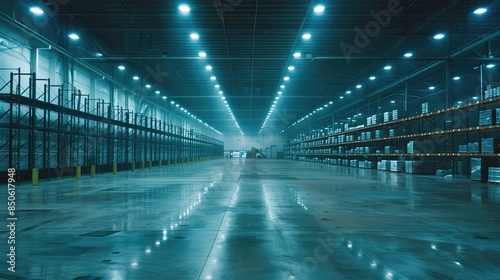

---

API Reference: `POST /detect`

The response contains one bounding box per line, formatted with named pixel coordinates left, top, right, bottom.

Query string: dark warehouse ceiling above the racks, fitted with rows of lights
left=13, top=0, right=500, bottom=135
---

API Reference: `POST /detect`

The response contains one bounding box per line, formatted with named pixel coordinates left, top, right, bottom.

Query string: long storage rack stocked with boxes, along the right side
left=284, top=97, right=500, bottom=181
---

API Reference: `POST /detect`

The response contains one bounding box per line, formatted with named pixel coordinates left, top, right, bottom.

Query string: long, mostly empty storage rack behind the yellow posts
left=0, top=69, right=224, bottom=180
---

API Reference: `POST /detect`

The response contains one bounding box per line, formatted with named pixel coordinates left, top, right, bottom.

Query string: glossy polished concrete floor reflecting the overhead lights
left=0, top=159, right=500, bottom=280
